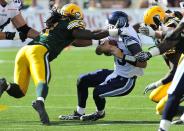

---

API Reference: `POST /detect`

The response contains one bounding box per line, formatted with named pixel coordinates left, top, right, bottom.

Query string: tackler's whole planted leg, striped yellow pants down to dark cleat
left=26, top=45, right=50, bottom=125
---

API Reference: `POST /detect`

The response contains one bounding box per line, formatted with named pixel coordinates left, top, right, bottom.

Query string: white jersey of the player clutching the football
left=109, top=26, right=144, bottom=78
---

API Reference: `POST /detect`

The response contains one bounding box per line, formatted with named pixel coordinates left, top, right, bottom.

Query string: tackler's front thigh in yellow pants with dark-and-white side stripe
left=26, top=45, right=51, bottom=85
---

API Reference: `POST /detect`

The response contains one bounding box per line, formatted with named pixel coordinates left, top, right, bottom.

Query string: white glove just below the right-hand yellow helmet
left=139, top=25, right=155, bottom=37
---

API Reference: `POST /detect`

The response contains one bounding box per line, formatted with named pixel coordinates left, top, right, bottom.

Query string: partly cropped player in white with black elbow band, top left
left=0, top=0, right=39, bottom=41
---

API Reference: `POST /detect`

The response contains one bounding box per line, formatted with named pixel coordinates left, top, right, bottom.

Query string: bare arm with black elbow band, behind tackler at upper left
left=12, top=12, right=39, bottom=41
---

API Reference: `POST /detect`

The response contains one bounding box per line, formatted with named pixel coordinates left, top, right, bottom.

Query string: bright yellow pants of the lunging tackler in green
left=14, top=45, right=50, bottom=94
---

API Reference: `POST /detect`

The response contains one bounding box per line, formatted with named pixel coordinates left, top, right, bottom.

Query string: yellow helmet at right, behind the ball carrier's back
left=144, top=6, right=166, bottom=28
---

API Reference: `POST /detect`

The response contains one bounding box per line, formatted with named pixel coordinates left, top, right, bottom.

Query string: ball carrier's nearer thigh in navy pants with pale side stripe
left=94, top=76, right=136, bottom=98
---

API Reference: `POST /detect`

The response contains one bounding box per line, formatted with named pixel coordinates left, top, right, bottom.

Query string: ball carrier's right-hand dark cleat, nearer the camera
left=80, top=112, right=105, bottom=121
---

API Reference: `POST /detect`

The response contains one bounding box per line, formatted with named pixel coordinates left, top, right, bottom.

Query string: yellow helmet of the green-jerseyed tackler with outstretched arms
left=59, top=3, right=84, bottom=20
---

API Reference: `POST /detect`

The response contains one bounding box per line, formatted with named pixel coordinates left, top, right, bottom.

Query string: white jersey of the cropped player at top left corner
left=0, top=0, right=21, bottom=31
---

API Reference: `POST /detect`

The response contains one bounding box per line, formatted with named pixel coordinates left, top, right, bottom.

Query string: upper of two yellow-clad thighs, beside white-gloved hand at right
left=149, top=82, right=171, bottom=102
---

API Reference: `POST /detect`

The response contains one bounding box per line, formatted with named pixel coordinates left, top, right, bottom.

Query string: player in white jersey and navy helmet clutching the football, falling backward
left=59, top=11, right=146, bottom=121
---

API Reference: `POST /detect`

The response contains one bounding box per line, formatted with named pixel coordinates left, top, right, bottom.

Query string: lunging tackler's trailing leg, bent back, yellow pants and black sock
left=0, top=46, right=30, bottom=98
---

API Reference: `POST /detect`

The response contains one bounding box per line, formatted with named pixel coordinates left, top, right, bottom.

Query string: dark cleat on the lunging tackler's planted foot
left=32, top=100, right=50, bottom=125
